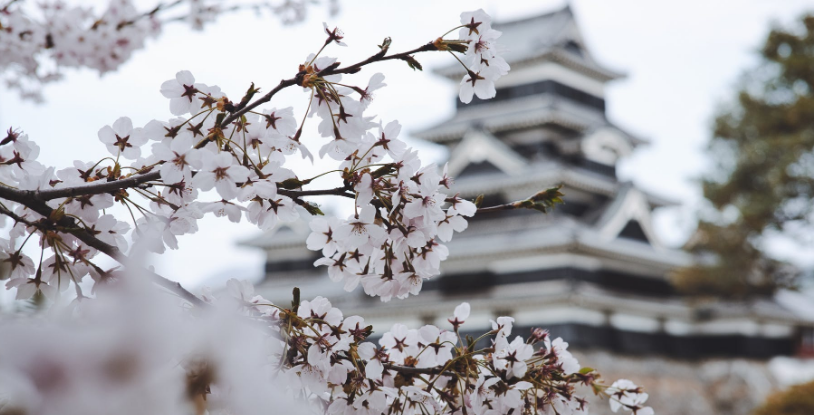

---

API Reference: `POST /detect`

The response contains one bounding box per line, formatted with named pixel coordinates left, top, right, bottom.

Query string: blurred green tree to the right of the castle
left=676, top=15, right=814, bottom=298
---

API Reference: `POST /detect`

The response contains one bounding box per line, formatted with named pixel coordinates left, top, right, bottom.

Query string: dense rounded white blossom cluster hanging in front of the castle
left=306, top=115, right=477, bottom=301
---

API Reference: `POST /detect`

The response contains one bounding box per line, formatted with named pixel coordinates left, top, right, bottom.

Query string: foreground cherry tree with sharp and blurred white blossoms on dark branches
left=0, top=10, right=653, bottom=415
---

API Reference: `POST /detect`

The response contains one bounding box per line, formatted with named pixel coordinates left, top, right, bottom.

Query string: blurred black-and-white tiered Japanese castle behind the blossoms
left=245, top=7, right=814, bottom=414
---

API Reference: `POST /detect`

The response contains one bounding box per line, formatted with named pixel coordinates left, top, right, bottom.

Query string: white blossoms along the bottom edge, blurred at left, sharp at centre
left=0, top=278, right=652, bottom=415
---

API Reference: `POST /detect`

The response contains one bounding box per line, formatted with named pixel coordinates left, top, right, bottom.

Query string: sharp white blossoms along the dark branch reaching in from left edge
left=0, top=9, right=504, bottom=301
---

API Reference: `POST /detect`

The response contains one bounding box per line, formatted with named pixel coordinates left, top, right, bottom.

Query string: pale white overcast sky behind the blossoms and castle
left=0, top=0, right=814, bottom=290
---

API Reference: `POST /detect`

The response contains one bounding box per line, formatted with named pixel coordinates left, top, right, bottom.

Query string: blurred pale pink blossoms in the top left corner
left=0, top=0, right=326, bottom=101
